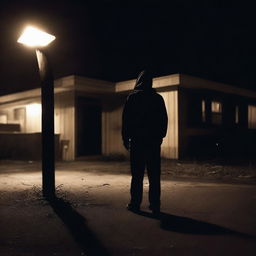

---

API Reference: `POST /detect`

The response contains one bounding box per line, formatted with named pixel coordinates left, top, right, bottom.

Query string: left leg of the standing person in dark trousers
left=128, top=143, right=145, bottom=210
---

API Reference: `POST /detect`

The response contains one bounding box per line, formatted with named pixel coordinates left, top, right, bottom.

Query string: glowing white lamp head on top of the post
left=17, top=26, right=56, bottom=47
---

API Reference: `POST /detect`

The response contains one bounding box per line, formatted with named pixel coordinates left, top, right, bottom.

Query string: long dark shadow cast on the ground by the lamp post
left=48, top=197, right=110, bottom=256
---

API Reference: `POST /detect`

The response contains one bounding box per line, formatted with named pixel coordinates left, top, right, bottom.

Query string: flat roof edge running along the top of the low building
left=0, top=74, right=256, bottom=105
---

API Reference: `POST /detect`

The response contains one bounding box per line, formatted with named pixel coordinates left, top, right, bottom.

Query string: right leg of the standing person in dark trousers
left=146, top=144, right=161, bottom=212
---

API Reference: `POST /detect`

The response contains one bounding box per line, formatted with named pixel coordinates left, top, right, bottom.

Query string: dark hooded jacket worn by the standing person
left=122, top=71, right=168, bottom=144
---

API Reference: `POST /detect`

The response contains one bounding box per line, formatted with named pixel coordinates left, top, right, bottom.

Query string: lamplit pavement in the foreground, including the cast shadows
left=0, top=163, right=256, bottom=256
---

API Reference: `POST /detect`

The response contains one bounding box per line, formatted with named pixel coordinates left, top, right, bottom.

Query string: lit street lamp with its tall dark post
left=17, top=26, right=55, bottom=199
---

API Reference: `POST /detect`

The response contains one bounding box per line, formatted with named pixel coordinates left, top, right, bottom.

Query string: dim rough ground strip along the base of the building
left=0, top=158, right=256, bottom=184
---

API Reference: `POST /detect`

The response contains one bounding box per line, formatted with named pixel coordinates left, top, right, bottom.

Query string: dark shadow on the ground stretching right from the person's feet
left=137, top=211, right=253, bottom=238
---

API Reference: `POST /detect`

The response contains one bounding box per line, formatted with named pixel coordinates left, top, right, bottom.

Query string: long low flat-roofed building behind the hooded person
left=0, top=74, right=256, bottom=160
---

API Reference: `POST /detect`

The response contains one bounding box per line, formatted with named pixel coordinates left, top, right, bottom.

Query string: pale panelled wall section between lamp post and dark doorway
left=54, top=91, right=75, bottom=160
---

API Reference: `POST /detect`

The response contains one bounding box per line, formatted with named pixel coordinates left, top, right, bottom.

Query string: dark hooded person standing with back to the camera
left=122, top=71, right=168, bottom=214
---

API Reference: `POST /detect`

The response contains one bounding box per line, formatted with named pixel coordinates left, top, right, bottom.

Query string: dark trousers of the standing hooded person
left=130, top=140, right=161, bottom=210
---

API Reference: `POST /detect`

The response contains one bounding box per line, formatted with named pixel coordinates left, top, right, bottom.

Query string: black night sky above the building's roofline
left=0, top=0, right=256, bottom=95
